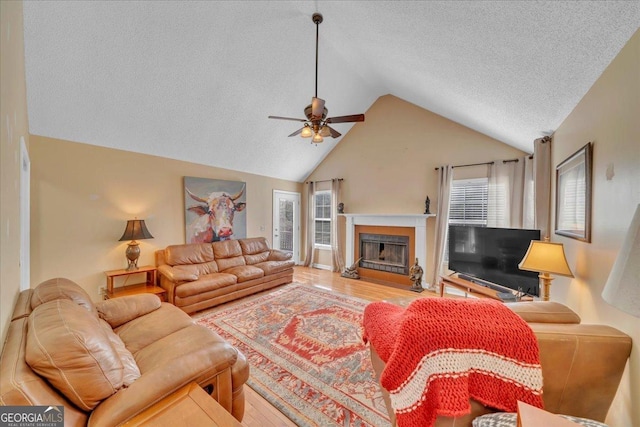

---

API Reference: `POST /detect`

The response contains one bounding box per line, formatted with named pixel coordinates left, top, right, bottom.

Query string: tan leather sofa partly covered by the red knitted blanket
left=370, top=301, right=631, bottom=427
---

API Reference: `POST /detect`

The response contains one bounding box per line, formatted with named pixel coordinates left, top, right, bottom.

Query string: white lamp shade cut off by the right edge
left=602, top=204, right=640, bottom=317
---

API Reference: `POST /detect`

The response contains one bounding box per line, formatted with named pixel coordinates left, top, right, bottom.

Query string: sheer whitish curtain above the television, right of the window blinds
left=487, top=156, right=534, bottom=228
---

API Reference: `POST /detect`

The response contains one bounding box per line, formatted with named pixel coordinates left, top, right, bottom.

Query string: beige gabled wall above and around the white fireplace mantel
left=309, top=95, right=525, bottom=278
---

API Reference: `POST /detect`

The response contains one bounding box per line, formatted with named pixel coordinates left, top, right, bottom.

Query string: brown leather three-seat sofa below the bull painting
left=156, top=237, right=294, bottom=313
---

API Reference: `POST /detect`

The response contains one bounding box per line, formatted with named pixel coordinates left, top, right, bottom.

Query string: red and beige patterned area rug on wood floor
left=194, top=283, right=389, bottom=427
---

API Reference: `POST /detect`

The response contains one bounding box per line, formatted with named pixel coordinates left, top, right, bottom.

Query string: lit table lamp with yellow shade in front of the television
left=518, top=237, right=573, bottom=301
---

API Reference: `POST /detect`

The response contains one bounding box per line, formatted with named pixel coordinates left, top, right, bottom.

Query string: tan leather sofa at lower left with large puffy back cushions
left=0, top=279, right=249, bottom=426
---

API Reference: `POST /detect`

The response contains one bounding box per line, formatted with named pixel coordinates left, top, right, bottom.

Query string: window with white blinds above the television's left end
left=449, top=178, right=489, bottom=226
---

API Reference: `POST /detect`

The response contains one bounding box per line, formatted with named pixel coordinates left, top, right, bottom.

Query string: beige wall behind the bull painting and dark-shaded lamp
left=31, top=135, right=301, bottom=299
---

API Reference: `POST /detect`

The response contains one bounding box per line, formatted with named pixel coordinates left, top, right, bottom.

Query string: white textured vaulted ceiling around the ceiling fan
left=24, top=0, right=640, bottom=181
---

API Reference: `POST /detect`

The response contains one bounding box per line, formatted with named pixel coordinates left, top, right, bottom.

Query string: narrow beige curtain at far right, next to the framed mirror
left=532, top=136, right=551, bottom=240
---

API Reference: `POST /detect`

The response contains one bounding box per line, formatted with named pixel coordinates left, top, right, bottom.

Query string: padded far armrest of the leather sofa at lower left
left=96, top=294, right=161, bottom=328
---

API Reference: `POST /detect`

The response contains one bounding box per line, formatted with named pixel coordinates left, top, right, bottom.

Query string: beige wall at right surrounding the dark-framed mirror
left=551, top=31, right=640, bottom=426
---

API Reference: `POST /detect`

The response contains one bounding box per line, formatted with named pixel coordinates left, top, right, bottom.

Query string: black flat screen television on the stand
left=449, top=225, right=540, bottom=296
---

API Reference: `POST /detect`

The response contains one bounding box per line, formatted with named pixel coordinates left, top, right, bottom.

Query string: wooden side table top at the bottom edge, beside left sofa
left=122, top=383, right=242, bottom=427
